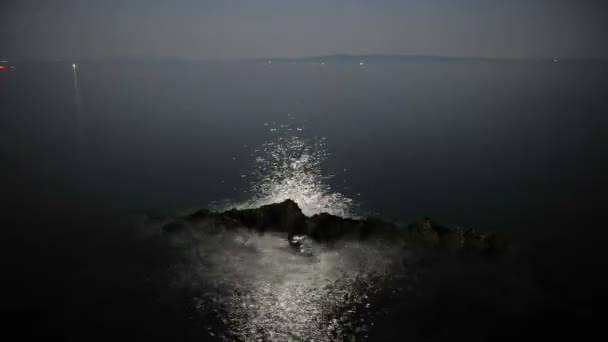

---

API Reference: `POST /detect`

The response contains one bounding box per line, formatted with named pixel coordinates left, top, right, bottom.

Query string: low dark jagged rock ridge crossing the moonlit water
left=161, top=200, right=506, bottom=253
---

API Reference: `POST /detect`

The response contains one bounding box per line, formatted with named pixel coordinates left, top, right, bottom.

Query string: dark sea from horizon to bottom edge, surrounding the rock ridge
left=0, top=62, right=608, bottom=340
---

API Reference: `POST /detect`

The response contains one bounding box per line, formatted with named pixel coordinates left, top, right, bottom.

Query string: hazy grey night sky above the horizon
left=0, top=0, right=608, bottom=59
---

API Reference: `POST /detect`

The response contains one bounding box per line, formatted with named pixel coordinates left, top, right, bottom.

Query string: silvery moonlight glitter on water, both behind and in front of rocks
left=164, top=125, right=407, bottom=341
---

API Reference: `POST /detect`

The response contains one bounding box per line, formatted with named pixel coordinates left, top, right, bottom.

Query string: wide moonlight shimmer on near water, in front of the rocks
left=173, top=230, right=406, bottom=341
